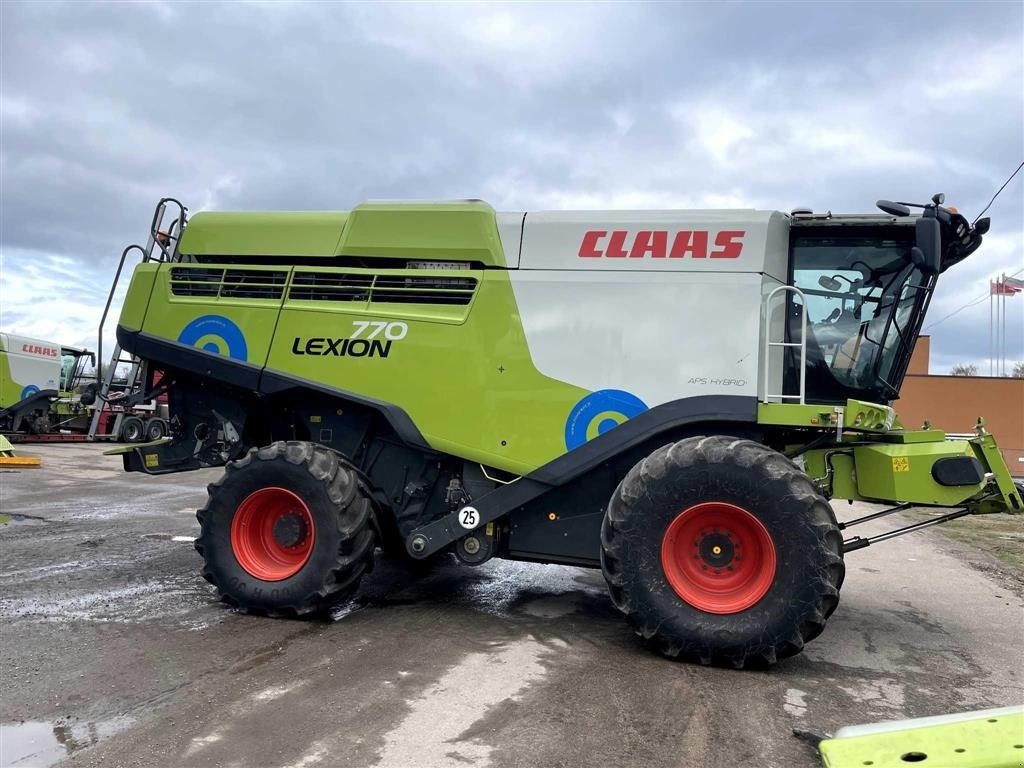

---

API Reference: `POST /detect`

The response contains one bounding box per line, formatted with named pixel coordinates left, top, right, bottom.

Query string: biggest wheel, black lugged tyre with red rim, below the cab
left=601, top=436, right=845, bottom=668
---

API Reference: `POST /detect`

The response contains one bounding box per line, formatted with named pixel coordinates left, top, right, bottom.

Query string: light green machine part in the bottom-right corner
left=818, top=709, right=1024, bottom=768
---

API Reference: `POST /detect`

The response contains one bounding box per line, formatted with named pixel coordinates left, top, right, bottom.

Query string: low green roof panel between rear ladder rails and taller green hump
left=178, top=211, right=348, bottom=257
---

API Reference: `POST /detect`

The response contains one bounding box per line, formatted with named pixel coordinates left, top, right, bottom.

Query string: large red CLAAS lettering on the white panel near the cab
left=580, top=229, right=746, bottom=259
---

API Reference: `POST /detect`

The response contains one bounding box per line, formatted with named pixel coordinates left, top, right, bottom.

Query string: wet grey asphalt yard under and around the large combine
left=0, top=444, right=1024, bottom=768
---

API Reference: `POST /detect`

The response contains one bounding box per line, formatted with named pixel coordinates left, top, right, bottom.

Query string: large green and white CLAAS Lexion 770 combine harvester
left=101, top=196, right=1022, bottom=667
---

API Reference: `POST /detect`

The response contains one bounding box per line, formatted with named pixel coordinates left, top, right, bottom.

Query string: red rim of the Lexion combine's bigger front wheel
left=662, top=502, right=775, bottom=613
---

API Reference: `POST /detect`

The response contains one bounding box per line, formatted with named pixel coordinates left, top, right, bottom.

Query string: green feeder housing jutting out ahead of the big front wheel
left=853, top=440, right=985, bottom=507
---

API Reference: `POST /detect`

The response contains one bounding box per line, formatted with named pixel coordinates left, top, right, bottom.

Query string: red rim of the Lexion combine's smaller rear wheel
left=231, top=487, right=316, bottom=582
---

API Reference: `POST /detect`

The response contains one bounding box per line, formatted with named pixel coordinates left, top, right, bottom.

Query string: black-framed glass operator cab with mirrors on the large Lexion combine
left=785, top=195, right=989, bottom=403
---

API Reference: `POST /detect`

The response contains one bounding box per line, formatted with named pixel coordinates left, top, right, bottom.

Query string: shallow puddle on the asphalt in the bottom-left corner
left=0, top=716, right=135, bottom=768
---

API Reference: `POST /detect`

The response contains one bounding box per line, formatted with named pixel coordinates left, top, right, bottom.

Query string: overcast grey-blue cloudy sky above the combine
left=0, top=0, right=1024, bottom=373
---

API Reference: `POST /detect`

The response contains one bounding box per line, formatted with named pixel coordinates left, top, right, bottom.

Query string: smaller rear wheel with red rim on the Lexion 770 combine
left=196, top=441, right=377, bottom=616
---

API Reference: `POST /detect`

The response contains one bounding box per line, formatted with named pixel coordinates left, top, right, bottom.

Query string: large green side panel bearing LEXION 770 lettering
left=133, top=260, right=588, bottom=474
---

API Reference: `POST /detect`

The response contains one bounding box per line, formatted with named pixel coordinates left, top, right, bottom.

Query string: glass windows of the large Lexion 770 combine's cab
left=787, top=234, right=932, bottom=402
